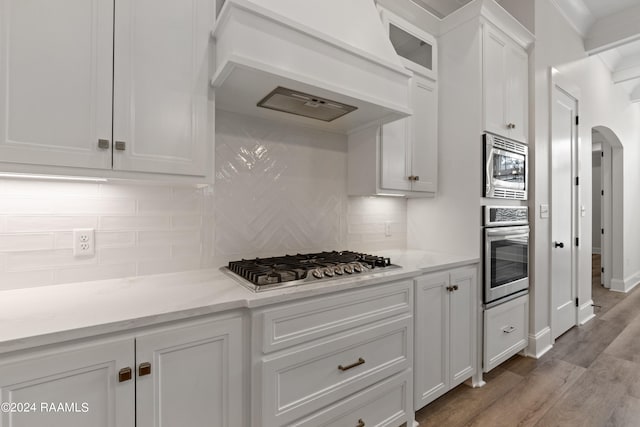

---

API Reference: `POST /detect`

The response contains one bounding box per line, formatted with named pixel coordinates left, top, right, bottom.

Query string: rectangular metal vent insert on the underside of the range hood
left=258, top=86, right=358, bottom=122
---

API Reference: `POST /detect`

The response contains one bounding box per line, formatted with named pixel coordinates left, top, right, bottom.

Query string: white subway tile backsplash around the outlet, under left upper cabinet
left=0, top=179, right=212, bottom=290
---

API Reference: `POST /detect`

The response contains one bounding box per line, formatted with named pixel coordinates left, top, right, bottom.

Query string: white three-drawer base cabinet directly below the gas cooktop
left=252, top=281, right=413, bottom=427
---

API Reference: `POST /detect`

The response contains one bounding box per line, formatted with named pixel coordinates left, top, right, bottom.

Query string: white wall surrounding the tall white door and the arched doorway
left=530, top=0, right=640, bottom=350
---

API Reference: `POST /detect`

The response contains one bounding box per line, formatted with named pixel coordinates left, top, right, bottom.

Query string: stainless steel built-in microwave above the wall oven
left=482, top=133, right=529, bottom=200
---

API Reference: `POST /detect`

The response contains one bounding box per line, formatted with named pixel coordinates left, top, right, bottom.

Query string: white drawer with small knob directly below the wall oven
left=484, top=295, right=529, bottom=372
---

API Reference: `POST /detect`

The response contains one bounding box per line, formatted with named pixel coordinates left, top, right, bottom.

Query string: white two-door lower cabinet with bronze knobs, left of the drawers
left=0, top=317, right=246, bottom=427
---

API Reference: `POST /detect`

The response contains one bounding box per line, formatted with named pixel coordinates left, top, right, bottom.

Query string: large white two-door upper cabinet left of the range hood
left=0, top=0, right=215, bottom=176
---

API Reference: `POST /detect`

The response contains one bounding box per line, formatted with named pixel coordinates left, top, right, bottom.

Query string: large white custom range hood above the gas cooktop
left=211, top=0, right=412, bottom=133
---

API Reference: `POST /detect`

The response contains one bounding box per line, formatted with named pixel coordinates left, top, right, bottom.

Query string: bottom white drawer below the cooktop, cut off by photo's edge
left=292, top=371, right=413, bottom=427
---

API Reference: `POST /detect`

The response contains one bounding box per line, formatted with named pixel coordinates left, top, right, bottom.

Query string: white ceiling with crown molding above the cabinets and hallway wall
left=412, top=0, right=640, bottom=102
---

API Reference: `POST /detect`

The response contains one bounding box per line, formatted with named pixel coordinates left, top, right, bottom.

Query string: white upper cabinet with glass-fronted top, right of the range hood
left=348, top=10, right=438, bottom=197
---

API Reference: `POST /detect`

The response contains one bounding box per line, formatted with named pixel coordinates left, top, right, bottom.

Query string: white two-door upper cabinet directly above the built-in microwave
left=482, top=23, right=529, bottom=142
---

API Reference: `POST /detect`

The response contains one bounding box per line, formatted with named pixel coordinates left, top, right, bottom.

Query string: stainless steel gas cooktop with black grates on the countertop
left=223, top=251, right=399, bottom=292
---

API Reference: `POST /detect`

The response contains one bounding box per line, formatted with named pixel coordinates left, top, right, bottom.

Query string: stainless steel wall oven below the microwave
left=484, top=206, right=529, bottom=308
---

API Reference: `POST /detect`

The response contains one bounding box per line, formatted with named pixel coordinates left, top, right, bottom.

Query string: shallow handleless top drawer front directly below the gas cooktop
left=257, top=281, right=413, bottom=354
